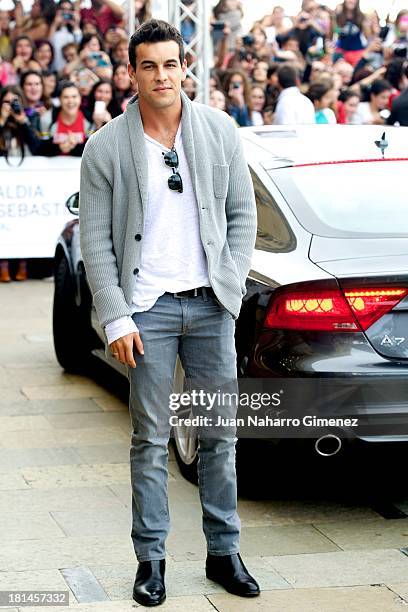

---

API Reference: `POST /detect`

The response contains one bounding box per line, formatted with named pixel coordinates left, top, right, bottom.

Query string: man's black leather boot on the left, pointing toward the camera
left=133, top=559, right=166, bottom=606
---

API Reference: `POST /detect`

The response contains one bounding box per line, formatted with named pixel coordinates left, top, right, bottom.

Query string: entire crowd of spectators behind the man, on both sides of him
left=0, top=0, right=408, bottom=167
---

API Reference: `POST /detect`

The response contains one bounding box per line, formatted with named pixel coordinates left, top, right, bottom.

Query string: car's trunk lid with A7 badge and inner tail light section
left=309, top=236, right=408, bottom=364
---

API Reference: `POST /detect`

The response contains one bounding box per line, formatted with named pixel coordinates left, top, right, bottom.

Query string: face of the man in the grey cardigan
left=128, top=40, right=187, bottom=109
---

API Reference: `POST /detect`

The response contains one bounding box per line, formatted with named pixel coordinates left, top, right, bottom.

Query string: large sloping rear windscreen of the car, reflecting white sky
left=273, top=161, right=408, bottom=237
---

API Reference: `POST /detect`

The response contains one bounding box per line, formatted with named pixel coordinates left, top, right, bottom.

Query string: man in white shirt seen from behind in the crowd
left=273, top=64, right=316, bottom=125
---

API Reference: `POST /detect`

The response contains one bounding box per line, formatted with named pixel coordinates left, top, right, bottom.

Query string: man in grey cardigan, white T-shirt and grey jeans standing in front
left=80, top=20, right=259, bottom=606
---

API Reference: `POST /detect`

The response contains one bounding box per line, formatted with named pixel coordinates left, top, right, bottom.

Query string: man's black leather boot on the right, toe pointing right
left=205, top=553, right=261, bottom=597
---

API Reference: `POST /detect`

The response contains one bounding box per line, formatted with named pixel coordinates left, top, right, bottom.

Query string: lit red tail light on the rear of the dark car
left=265, top=283, right=408, bottom=332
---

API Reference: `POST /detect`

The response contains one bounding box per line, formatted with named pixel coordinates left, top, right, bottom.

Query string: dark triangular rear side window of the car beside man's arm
left=251, top=170, right=296, bottom=253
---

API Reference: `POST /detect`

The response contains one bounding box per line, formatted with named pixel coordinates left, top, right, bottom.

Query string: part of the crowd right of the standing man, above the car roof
left=206, top=0, right=408, bottom=126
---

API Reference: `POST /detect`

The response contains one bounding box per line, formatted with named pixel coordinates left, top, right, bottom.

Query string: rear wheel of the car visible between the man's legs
left=172, top=359, right=198, bottom=484
